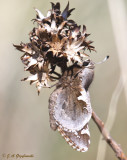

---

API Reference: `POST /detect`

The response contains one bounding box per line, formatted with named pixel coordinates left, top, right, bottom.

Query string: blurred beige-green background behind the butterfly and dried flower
left=0, top=0, right=127, bottom=160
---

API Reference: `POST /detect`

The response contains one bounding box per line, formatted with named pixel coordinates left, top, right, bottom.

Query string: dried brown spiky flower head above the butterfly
left=14, top=3, right=94, bottom=93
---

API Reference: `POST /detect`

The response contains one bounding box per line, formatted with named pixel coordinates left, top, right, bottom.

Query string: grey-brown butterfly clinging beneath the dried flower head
left=49, top=60, right=94, bottom=152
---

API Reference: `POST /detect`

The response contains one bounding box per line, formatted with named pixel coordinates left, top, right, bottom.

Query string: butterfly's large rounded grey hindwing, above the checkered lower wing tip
left=49, top=87, right=92, bottom=132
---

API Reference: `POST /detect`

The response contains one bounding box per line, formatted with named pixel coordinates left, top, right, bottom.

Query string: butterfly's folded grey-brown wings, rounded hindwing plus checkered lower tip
left=49, top=87, right=92, bottom=152
